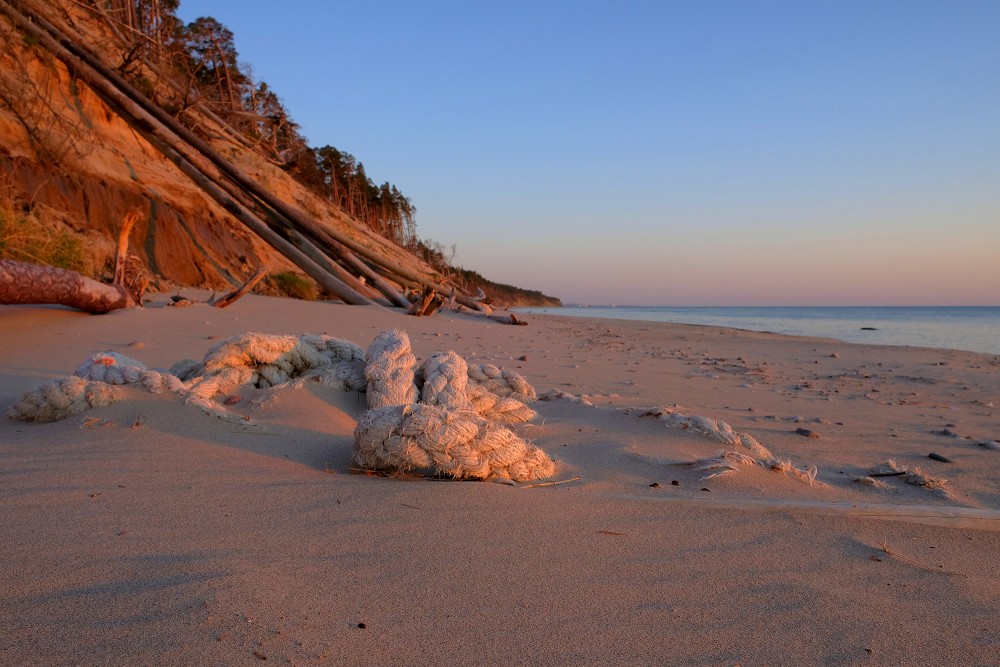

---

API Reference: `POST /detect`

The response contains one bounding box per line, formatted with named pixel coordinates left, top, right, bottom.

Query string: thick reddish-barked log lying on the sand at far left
left=0, top=259, right=141, bottom=313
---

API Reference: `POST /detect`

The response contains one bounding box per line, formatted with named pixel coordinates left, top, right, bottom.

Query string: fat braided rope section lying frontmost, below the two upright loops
left=354, top=404, right=555, bottom=482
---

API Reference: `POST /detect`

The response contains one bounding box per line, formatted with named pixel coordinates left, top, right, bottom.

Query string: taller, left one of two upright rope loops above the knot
left=365, top=329, right=418, bottom=408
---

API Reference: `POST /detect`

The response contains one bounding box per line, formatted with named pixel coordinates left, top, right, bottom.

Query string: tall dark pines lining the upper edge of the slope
left=106, top=0, right=417, bottom=247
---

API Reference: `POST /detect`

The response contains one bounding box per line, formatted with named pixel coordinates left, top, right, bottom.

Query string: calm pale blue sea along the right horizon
left=517, top=306, right=1000, bottom=354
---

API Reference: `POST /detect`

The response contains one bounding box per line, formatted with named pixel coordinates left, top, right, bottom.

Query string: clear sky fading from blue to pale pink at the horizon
left=179, top=0, right=1000, bottom=306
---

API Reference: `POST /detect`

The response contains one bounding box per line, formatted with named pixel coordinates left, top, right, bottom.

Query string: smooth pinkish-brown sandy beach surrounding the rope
left=0, top=292, right=1000, bottom=665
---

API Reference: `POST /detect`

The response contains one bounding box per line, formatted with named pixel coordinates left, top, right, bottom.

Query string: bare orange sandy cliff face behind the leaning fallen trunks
left=0, top=3, right=325, bottom=288
